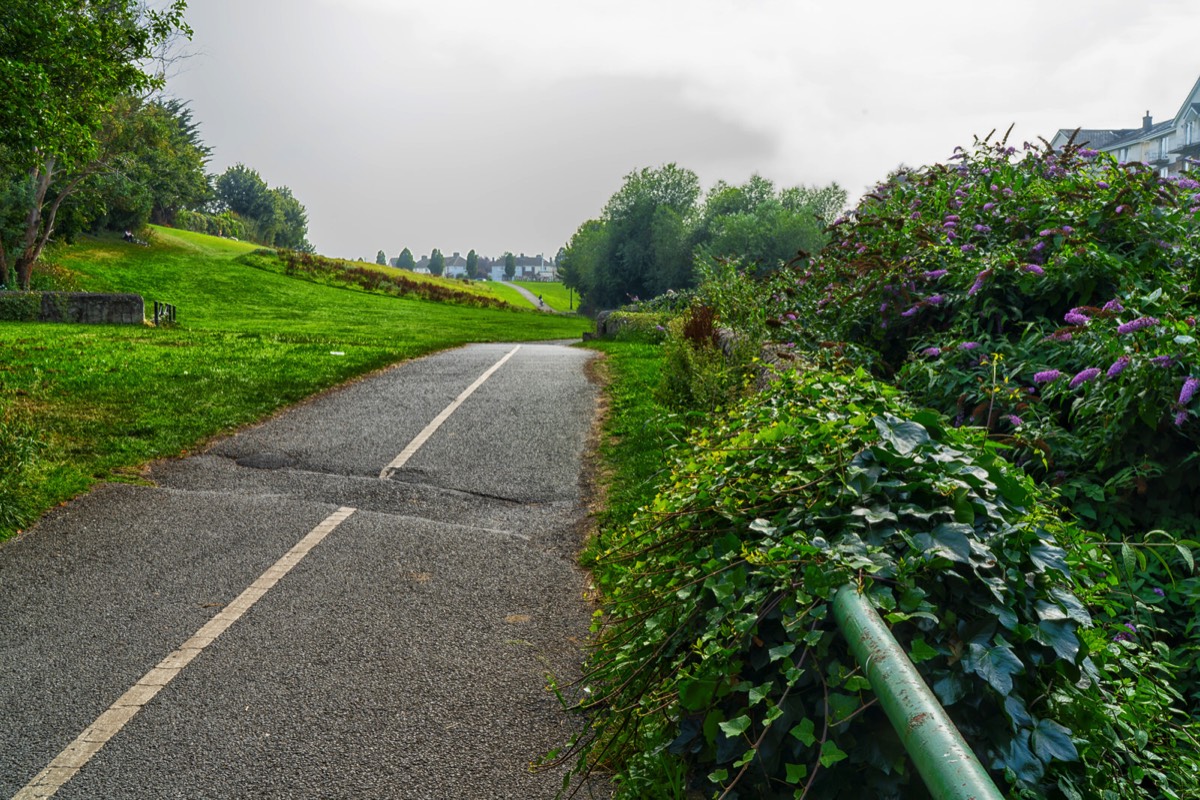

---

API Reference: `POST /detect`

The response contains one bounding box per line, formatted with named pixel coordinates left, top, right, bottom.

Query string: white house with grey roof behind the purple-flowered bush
left=1050, top=73, right=1200, bottom=178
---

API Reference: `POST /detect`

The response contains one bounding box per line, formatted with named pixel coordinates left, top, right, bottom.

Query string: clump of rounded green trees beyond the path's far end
left=558, top=164, right=846, bottom=308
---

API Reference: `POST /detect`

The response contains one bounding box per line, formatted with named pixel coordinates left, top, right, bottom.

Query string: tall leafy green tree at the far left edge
left=0, top=0, right=191, bottom=289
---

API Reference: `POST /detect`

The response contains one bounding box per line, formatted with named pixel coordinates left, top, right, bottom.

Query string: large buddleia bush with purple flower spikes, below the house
left=758, top=136, right=1200, bottom=718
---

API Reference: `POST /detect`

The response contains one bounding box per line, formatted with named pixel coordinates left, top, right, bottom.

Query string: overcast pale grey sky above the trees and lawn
left=168, top=0, right=1200, bottom=260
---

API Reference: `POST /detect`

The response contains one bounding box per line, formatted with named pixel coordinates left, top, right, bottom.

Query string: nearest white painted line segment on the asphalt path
left=12, top=506, right=354, bottom=800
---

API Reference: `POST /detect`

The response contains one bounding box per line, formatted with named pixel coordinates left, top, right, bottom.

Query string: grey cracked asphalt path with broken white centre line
left=0, top=344, right=596, bottom=800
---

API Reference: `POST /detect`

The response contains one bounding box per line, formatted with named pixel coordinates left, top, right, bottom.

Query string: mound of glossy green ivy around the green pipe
left=568, top=371, right=1195, bottom=799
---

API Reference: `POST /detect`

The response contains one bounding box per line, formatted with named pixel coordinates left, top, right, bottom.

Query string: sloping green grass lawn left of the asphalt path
left=0, top=229, right=590, bottom=539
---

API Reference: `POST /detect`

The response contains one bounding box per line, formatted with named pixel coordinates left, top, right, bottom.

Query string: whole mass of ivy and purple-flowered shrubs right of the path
left=573, top=136, right=1200, bottom=800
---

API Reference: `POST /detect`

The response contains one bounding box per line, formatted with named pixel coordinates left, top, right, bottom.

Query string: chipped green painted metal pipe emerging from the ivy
left=833, top=585, right=1004, bottom=800
